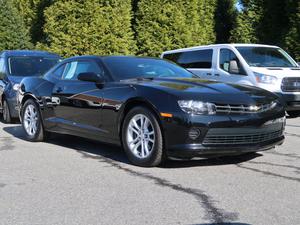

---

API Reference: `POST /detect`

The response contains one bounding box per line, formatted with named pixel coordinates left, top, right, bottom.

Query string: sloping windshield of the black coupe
left=103, top=57, right=195, bottom=80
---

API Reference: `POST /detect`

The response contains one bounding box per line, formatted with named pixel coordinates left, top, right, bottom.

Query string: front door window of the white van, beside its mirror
left=219, top=49, right=246, bottom=75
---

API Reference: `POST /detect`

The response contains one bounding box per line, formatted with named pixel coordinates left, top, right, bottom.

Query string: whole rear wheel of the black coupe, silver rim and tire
left=22, top=99, right=45, bottom=142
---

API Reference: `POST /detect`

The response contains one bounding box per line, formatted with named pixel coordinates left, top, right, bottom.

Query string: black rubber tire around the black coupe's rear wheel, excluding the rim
left=21, top=99, right=46, bottom=142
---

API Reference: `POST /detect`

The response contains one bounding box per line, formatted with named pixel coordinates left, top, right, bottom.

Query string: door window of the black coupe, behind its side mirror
left=62, top=60, right=103, bottom=80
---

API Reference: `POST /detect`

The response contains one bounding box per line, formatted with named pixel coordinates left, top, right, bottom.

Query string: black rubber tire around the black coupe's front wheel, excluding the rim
left=122, top=107, right=166, bottom=167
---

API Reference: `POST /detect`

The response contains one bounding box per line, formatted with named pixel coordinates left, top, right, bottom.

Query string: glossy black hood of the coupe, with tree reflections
left=131, top=78, right=278, bottom=105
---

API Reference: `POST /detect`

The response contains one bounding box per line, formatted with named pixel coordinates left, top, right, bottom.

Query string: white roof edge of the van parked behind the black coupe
left=162, top=44, right=279, bottom=54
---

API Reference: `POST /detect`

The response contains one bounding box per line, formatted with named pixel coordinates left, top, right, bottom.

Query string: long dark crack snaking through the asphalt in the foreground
left=78, top=151, right=238, bottom=224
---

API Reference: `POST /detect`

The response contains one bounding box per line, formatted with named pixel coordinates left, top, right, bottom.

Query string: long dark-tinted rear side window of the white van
left=164, top=49, right=213, bottom=69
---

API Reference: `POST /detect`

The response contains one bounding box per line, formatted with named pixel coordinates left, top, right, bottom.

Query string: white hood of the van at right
left=251, top=67, right=300, bottom=78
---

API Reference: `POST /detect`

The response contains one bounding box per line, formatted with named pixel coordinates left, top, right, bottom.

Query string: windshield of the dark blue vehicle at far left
left=8, top=56, right=59, bottom=77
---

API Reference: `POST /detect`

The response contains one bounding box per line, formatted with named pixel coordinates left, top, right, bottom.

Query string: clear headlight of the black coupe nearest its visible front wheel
left=178, top=100, right=216, bottom=115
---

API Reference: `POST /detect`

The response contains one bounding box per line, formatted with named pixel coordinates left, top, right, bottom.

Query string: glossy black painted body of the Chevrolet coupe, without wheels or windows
left=18, top=56, right=285, bottom=157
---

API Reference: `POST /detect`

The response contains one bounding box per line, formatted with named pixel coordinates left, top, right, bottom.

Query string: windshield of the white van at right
left=236, top=47, right=297, bottom=67
